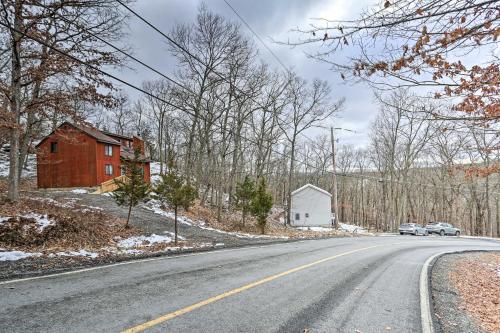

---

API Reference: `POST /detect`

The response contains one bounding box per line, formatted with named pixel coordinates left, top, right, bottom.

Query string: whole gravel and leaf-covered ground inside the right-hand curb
left=431, top=252, right=500, bottom=333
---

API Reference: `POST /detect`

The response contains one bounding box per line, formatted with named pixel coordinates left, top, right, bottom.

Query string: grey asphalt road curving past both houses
left=0, top=236, right=500, bottom=333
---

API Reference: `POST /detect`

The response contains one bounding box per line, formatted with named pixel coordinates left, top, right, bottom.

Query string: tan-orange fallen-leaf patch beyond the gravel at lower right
left=450, top=253, right=500, bottom=333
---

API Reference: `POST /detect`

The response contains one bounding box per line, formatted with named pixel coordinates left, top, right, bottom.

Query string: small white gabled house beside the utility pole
left=290, top=184, right=332, bottom=227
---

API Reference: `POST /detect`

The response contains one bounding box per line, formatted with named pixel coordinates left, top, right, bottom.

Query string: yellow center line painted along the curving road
left=122, top=245, right=382, bottom=333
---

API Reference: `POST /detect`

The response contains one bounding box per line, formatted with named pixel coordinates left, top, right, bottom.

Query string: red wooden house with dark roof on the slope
left=37, top=122, right=150, bottom=188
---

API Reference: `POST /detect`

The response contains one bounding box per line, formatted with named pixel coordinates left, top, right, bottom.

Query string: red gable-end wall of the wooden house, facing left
left=37, top=126, right=98, bottom=188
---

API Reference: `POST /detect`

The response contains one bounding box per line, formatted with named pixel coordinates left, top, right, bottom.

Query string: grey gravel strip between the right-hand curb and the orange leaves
left=431, top=252, right=500, bottom=333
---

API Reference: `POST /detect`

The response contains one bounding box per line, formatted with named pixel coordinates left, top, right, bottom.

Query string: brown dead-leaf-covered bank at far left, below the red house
left=0, top=196, right=139, bottom=252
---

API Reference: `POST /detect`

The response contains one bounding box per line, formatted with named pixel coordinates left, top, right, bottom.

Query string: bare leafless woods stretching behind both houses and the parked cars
left=0, top=0, right=500, bottom=236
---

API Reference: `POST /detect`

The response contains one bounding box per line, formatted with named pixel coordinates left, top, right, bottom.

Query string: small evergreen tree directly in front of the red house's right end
left=112, top=149, right=150, bottom=228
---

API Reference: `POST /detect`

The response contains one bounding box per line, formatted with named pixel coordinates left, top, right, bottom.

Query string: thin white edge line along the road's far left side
left=0, top=239, right=307, bottom=286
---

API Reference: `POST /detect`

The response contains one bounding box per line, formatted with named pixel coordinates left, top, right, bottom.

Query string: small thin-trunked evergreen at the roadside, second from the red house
left=155, top=163, right=197, bottom=245
